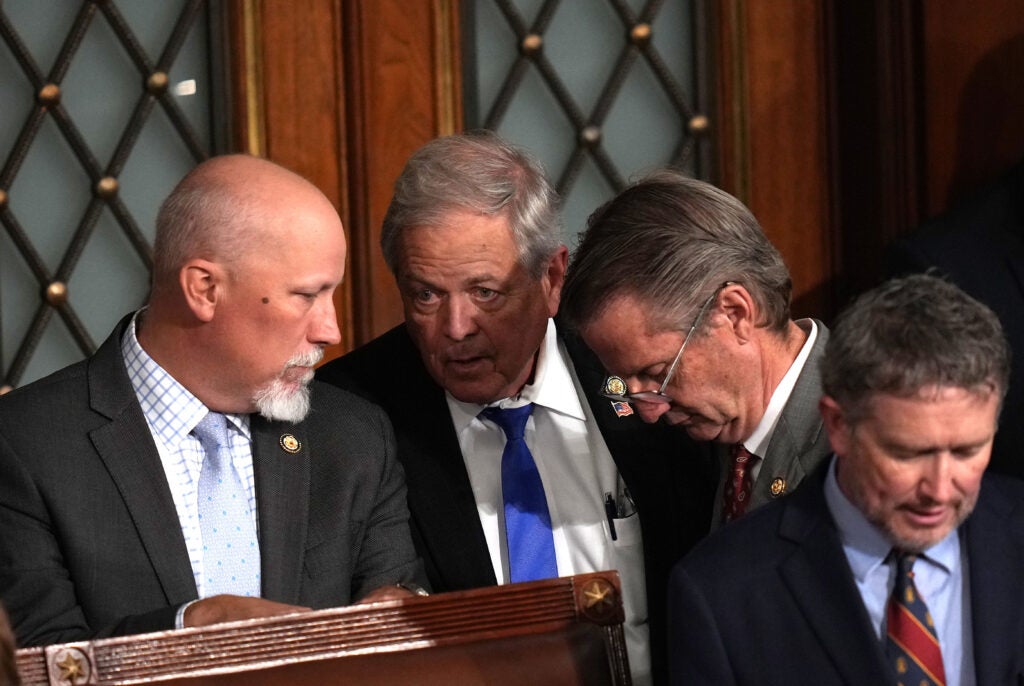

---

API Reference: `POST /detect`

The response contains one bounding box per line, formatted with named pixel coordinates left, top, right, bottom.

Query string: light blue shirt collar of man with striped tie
left=825, top=455, right=959, bottom=582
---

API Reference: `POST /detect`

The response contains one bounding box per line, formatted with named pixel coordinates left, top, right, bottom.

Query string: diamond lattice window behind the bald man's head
left=0, top=0, right=212, bottom=387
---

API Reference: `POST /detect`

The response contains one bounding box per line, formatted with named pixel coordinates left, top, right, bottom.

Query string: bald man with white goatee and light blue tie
left=0, top=156, right=419, bottom=645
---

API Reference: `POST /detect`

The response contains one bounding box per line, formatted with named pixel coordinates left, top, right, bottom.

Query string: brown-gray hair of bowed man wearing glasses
left=561, top=170, right=793, bottom=332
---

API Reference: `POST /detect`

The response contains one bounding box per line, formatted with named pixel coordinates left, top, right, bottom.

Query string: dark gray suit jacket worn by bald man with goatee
left=0, top=321, right=421, bottom=645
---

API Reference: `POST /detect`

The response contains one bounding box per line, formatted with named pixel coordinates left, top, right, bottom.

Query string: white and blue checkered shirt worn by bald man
left=121, top=310, right=259, bottom=602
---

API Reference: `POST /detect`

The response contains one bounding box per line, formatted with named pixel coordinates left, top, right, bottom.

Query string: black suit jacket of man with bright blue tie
left=317, top=325, right=717, bottom=675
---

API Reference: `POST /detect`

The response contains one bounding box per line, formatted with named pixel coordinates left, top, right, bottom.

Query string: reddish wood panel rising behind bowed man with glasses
left=716, top=0, right=835, bottom=316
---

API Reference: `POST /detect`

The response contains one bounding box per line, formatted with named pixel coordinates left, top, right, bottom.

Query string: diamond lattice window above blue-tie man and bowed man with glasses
left=464, top=0, right=710, bottom=247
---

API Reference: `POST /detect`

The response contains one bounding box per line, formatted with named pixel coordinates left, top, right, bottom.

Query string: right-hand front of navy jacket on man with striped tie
left=967, top=481, right=1024, bottom=684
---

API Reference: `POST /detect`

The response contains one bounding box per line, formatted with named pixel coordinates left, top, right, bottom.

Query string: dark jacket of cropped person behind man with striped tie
left=888, top=162, right=1024, bottom=478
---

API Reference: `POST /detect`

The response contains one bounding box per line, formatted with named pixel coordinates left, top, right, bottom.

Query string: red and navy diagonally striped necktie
left=886, top=550, right=946, bottom=686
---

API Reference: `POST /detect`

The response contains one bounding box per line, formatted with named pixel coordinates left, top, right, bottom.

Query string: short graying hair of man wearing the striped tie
left=821, top=274, right=1010, bottom=423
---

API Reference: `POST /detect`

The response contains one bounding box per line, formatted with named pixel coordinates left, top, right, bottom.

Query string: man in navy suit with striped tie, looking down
left=670, top=275, right=1024, bottom=686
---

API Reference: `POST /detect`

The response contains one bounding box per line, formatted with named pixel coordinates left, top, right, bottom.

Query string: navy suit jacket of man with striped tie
left=669, top=466, right=1024, bottom=686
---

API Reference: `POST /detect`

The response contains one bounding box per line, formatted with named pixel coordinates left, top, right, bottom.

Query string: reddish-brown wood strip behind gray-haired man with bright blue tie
left=342, top=0, right=462, bottom=344
